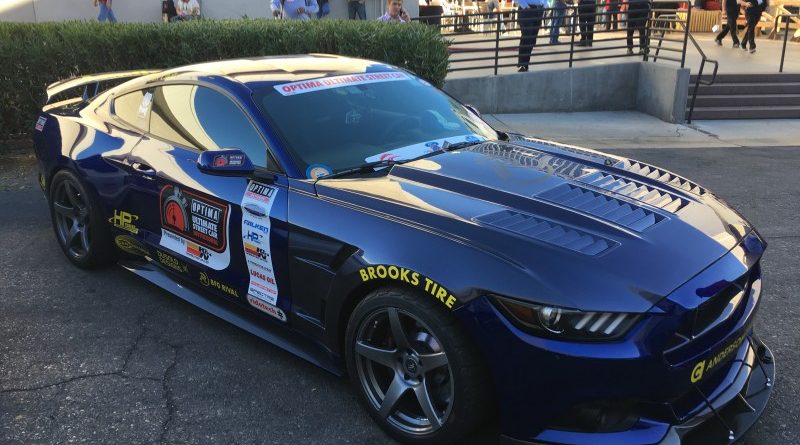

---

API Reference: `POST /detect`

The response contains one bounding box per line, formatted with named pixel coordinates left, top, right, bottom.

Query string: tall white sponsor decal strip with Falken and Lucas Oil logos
left=242, top=181, right=286, bottom=312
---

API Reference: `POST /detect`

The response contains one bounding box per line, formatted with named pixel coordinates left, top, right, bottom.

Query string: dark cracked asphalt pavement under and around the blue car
left=0, top=140, right=800, bottom=444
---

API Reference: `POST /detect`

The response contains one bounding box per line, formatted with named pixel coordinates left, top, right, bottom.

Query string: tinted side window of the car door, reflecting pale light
left=150, top=85, right=267, bottom=167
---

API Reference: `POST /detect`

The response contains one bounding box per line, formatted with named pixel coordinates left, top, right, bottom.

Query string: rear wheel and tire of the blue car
left=48, top=170, right=117, bottom=269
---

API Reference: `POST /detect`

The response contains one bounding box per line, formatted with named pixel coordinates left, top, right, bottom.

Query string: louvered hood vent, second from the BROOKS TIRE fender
left=536, top=184, right=664, bottom=232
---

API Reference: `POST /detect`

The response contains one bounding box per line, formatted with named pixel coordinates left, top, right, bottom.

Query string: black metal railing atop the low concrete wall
left=414, top=0, right=692, bottom=74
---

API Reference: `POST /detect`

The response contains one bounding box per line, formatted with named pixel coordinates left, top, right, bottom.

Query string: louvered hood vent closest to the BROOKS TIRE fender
left=475, top=210, right=616, bottom=255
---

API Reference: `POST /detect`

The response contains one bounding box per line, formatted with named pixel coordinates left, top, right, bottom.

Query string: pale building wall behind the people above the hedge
left=0, top=0, right=412, bottom=22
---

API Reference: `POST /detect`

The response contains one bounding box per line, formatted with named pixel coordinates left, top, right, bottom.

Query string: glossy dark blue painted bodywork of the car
left=34, top=56, right=766, bottom=443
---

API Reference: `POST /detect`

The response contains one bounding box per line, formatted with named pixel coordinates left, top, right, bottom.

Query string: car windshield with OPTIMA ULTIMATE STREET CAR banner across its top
left=254, top=72, right=497, bottom=178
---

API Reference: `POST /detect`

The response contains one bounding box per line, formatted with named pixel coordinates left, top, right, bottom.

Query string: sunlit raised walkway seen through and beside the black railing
left=447, top=31, right=800, bottom=79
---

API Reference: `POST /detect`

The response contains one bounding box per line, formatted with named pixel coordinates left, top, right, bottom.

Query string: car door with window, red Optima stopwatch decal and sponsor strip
left=122, top=84, right=290, bottom=321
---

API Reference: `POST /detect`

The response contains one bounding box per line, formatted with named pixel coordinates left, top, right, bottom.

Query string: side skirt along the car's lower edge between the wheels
left=120, top=261, right=344, bottom=376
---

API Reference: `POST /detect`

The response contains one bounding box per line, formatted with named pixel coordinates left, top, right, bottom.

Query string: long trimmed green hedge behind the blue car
left=0, top=19, right=448, bottom=138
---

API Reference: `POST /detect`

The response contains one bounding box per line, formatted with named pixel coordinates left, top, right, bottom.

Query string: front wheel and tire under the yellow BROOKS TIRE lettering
left=345, top=288, right=492, bottom=444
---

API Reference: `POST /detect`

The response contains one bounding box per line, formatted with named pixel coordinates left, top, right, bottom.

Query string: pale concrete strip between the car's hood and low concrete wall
left=483, top=111, right=800, bottom=149
